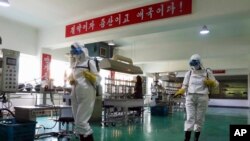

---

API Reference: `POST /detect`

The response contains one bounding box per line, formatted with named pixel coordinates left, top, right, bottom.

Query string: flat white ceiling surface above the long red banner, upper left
left=0, top=0, right=160, bottom=28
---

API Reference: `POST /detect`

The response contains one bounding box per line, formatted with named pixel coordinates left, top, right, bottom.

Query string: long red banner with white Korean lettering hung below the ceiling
left=65, top=0, right=192, bottom=37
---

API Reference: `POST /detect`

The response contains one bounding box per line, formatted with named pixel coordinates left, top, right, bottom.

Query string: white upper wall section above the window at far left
left=0, top=17, right=38, bottom=55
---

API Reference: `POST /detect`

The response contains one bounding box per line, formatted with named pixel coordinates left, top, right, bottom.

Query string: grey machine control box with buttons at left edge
left=0, top=49, right=20, bottom=92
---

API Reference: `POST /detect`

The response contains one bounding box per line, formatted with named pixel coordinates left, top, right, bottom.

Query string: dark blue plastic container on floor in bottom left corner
left=0, top=118, right=36, bottom=141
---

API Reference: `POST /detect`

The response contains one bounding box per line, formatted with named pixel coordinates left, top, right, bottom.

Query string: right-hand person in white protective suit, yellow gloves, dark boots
left=175, top=54, right=219, bottom=141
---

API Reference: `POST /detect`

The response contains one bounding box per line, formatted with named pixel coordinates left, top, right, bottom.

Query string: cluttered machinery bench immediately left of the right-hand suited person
left=151, top=72, right=185, bottom=115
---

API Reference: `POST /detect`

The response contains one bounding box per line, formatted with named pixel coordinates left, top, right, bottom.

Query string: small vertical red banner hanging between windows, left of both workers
left=41, top=54, right=51, bottom=80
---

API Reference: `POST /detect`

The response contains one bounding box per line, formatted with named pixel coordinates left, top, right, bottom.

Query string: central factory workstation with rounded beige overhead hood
left=100, top=55, right=144, bottom=126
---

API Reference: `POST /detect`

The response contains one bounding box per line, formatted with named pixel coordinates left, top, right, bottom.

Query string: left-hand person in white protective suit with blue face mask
left=69, top=43, right=101, bottom=141
